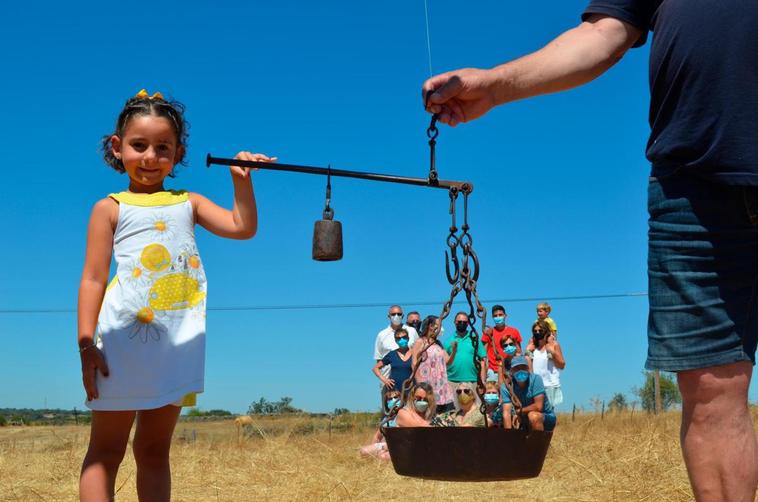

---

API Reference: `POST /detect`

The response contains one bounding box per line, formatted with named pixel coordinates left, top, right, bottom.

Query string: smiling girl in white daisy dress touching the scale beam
left=78, top=90, right=275, bottom=501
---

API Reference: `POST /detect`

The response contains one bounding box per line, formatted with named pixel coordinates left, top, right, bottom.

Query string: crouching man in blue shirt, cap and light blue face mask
left=500, top=356, right=556, bottom=431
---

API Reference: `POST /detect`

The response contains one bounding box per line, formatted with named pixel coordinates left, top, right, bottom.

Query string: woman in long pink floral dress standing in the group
left=413, top=315, right=457, bottom=413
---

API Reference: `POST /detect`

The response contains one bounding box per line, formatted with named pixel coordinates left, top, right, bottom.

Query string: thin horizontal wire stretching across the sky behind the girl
left=0, top=291, right=647, bottom=314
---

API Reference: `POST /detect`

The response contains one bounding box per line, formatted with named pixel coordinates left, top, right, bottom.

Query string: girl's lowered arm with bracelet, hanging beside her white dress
left=77, top=198, right=118, bottom=400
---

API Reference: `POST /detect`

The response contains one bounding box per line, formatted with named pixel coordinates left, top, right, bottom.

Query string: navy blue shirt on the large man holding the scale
left=582, top=0, right=758, bottom=185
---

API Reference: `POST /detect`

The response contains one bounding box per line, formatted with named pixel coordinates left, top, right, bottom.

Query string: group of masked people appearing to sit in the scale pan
left=361, top=303, right=566, bottom=460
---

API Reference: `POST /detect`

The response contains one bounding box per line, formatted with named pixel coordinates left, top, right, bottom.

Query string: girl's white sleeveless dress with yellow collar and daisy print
left=85, top=191, right=207, bottom=410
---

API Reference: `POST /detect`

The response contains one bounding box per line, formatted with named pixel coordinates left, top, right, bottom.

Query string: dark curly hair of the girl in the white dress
left=101, top=91, right=189, bottom=176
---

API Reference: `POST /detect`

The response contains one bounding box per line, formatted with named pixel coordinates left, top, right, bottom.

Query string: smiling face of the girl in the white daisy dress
left=111, top=115, right=184, bottom=193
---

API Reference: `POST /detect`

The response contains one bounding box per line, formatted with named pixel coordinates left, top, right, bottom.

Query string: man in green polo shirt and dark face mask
left=444, top=312, right=487, bottom=411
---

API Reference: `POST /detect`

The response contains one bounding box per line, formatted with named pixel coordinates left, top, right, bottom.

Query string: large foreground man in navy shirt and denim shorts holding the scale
left=423, top=0, right=758, bottom=501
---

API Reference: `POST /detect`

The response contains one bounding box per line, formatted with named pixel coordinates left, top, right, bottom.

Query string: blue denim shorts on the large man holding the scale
left=645, top=172, right=758, bottom=371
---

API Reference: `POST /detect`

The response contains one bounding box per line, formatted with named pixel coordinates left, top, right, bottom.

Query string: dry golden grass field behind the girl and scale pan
left=0, top=409, right=758, bottom=502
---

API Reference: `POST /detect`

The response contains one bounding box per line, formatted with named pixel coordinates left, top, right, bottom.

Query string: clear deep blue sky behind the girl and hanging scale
left=0, top=0, right=758, bottom=412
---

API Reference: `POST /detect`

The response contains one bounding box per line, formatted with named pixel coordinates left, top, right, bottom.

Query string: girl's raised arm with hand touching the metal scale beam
left=190, top=152, right=276, bottom=239
